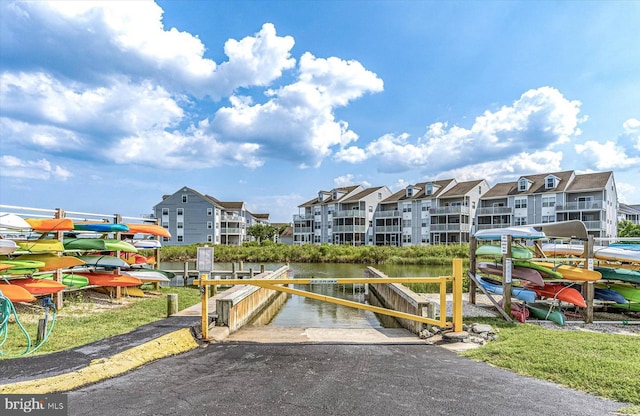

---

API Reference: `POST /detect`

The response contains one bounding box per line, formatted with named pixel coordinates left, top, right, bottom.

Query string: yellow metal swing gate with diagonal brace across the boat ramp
left=198, top=259, right=462, bottom=339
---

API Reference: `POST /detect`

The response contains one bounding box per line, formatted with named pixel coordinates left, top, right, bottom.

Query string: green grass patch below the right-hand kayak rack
left=463, top=319, right=640, bottom=406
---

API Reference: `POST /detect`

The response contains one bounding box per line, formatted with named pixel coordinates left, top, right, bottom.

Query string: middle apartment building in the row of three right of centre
left=374, top=179, right=489, bottom=246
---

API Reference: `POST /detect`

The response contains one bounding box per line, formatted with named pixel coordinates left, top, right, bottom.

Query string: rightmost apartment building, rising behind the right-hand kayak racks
left=477, top=171, right=618, bottom=237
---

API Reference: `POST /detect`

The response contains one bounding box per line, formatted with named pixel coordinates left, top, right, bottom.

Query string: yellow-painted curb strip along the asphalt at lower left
left=0, top=328, right=199, bottom=394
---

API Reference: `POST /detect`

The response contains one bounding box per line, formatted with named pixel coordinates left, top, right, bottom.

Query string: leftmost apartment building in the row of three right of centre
left=293, top=185, right=391, bottom=245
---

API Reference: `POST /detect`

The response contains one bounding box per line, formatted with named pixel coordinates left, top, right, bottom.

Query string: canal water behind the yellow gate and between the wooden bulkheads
left=160, top=263, right=451, bottom=328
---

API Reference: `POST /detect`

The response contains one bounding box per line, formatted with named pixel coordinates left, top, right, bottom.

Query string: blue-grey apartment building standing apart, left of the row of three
left=153, top=186, right=269, bottom=245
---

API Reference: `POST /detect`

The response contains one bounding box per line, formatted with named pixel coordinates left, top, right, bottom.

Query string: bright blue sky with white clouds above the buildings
left=0, top=0, right=640, bottom=222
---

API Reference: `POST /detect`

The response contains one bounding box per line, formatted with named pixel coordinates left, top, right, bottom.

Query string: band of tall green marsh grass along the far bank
left=150, top=241, right=469, bottom=265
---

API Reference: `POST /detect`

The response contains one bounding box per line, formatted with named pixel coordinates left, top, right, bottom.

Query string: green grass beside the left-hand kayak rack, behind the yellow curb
left=0, top=287, right=200, bottom=359
